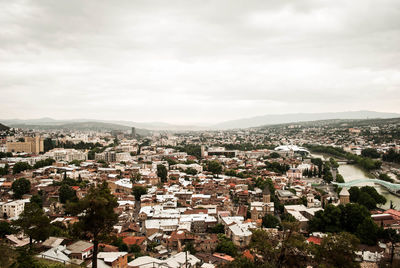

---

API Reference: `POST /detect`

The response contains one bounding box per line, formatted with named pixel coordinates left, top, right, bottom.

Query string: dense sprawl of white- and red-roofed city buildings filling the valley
left=0, top=122, right=400, bottom=268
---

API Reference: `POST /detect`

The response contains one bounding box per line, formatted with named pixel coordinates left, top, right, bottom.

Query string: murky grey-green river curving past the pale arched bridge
left=312, top=154, right=400, bottom=209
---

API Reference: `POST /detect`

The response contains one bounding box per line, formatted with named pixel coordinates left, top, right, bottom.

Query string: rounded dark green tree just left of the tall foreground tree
left=14, top=203, right=50, bottom=247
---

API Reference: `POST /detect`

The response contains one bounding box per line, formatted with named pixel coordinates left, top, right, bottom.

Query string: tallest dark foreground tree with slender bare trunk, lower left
left=71, top=182, right=118, bottom=268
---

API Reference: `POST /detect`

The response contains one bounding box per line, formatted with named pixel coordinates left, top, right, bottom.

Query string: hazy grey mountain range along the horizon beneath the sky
left=0, top=111, right=400, bottom=131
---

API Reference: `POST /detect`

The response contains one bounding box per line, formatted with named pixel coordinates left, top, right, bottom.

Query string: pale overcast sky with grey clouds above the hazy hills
left=0, top=0, right=400, bottom=123
